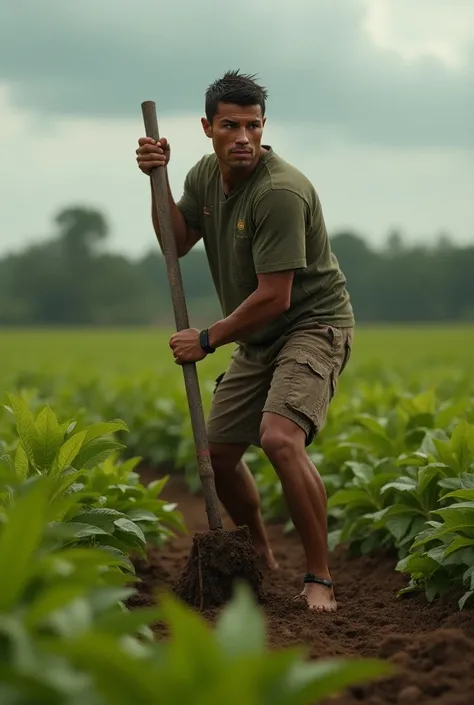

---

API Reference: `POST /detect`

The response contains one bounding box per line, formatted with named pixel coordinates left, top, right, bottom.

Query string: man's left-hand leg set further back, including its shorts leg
left=207, top=354, right=278, bottom=569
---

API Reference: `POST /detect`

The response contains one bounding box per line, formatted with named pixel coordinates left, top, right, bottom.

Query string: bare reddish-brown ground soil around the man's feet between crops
left=133, top=473, right=474, bottom=705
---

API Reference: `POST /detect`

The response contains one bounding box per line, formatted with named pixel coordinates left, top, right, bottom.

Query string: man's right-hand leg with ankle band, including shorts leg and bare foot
left=260, top=326, right=352, bottom=611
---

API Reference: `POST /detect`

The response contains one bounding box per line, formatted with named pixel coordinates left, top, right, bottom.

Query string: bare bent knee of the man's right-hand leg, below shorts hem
left=260, top=414, right=306, bottom=467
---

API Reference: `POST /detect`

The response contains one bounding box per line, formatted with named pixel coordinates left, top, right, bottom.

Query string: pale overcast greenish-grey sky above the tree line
left=0, top=0, right=474, bottom=255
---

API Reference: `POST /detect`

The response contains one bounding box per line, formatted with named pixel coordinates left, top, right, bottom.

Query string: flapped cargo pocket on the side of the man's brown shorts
left=285, top=350, right=336, bottom=433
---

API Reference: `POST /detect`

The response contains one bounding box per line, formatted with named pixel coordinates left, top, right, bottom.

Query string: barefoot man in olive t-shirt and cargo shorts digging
left=136, top=71, right=354, bottom=611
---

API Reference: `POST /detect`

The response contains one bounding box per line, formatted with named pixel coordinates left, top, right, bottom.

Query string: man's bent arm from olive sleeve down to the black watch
left=209, top=189, right=307, bottom=347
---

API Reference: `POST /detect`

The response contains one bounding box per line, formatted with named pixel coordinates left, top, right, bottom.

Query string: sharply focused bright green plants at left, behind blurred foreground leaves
left=0, top=395, right=185, bottom=568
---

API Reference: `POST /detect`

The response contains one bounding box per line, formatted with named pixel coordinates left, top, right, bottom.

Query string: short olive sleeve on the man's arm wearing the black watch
left=252, top=189, right=308, bottom=274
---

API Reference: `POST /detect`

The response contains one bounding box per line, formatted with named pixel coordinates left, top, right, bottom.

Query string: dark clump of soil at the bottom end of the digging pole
left=174, top=526, right=263, bottom=610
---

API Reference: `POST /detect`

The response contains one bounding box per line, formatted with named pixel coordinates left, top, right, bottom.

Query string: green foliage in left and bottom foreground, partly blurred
left=0, top=396, right=392, bottom=705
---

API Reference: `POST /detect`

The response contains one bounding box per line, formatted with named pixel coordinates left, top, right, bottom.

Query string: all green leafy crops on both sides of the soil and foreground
left=0, top=352, right=474, bottom=705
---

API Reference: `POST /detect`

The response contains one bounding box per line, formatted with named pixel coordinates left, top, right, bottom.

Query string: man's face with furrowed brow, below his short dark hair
left=201, top=103, right=265, bottom=169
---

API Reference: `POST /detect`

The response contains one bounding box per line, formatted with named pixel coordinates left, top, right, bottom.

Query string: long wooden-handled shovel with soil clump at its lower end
left=142, top=100, right=262, bottom=610
